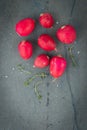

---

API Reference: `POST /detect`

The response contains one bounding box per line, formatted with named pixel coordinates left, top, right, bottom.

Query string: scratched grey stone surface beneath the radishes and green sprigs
left=0, top=0, right=87, bottom=130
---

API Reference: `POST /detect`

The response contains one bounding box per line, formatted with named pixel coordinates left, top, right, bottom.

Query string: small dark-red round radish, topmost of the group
left=39, top=13, right=54, bottom=28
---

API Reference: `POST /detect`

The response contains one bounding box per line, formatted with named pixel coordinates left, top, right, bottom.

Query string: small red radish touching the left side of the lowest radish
left=34, top=54, right=49, bottom=68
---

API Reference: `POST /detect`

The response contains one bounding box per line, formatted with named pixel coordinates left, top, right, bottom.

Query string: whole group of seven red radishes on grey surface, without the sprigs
left=15, top=13, right=76, bottom=78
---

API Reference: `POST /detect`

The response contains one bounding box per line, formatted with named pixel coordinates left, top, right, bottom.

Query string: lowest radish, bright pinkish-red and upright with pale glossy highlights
left=50, top=56, right=67, bottom=78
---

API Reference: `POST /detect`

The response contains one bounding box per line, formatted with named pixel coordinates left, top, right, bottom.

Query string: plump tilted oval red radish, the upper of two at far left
left=15, top=18, right=35, bottom=36
